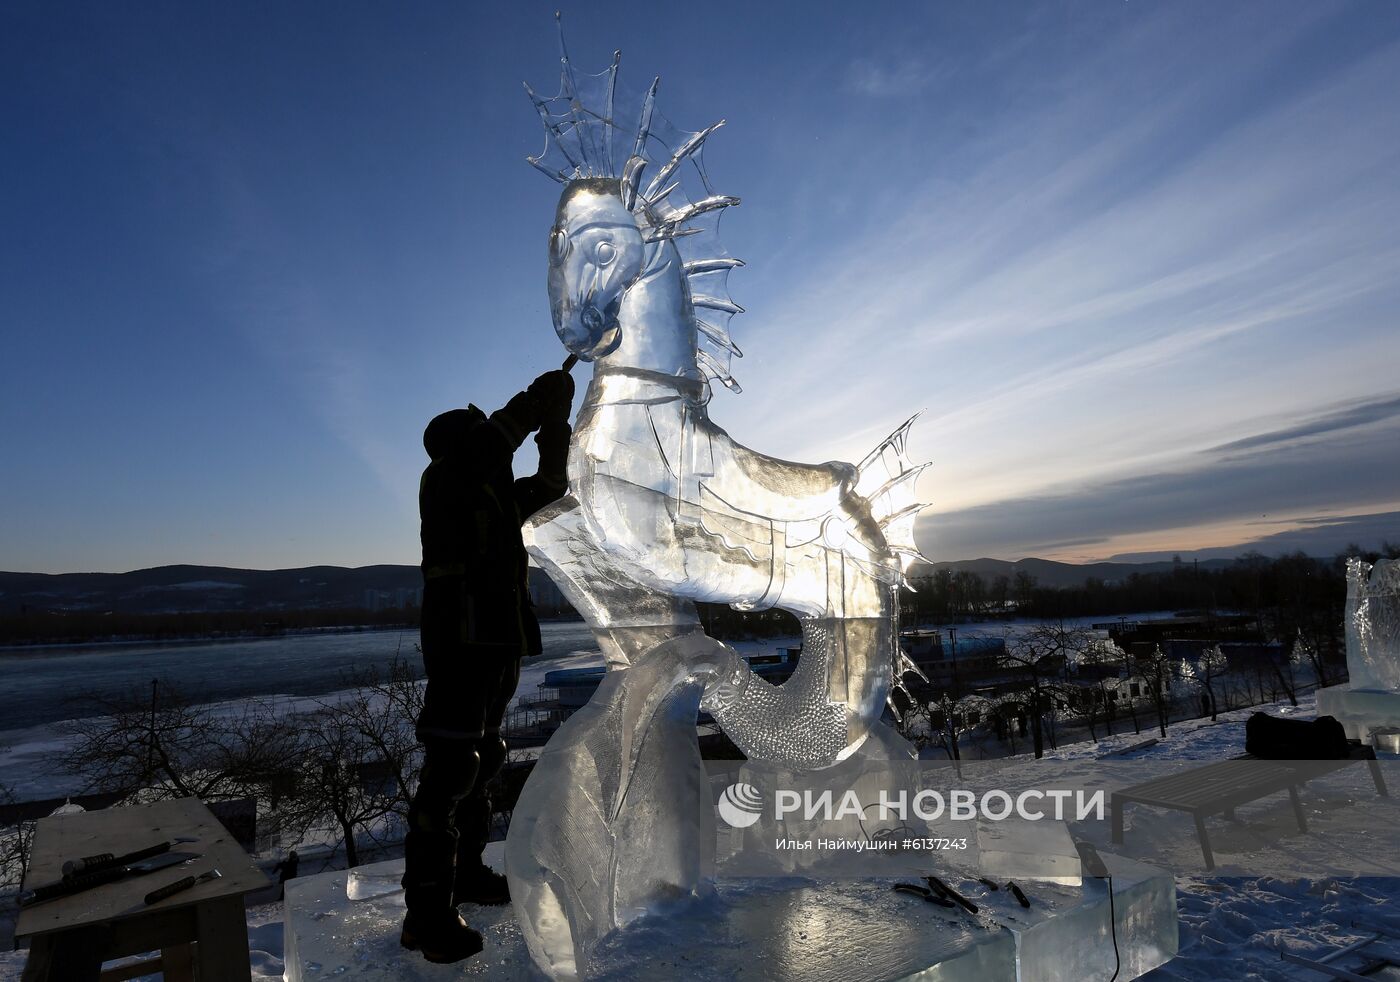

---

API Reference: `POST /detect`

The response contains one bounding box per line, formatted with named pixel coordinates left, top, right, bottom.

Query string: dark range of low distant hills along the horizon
left=0, top=559, right=1233, bottom=615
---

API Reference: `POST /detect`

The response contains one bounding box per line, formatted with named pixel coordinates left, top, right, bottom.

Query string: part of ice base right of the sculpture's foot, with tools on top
left=579, top=856, right=1177, bottom=982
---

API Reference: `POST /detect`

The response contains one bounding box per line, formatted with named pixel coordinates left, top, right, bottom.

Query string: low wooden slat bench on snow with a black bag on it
left=1110, top=744, right=1390, bottom=870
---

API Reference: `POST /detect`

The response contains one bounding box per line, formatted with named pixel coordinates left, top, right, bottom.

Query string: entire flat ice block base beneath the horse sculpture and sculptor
left=286, top=856, right=1177, bottom=982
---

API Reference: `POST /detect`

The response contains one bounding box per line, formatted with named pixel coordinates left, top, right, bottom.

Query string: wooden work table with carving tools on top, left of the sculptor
left=15, top=798, right=269, bottom=982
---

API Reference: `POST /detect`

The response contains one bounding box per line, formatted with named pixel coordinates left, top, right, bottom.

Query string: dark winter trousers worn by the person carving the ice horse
left=403, top=635, right=521, bottom=916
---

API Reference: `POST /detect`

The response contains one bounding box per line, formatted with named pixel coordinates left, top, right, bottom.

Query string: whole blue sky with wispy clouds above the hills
left=0, top=0, right=1400, bottom=572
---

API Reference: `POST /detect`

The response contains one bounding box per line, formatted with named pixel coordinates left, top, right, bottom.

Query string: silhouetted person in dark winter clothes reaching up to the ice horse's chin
left=402, top=371, right=574, bottom=961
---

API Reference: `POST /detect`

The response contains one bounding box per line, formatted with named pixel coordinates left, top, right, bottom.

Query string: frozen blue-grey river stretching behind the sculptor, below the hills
left=0, top=621, right=598, bottom=731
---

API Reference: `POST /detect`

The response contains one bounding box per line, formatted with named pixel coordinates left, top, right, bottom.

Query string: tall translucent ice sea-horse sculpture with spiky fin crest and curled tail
left=507, top=26, right=923, bottom=978
